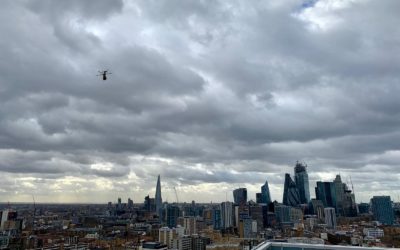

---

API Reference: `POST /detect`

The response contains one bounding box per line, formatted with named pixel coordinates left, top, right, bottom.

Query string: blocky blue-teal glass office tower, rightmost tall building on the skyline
left=371, top=196, right=394, bottom=225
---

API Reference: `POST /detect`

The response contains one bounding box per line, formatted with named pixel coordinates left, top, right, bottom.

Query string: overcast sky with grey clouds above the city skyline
left=0, top=0, right=400, bottom=203
